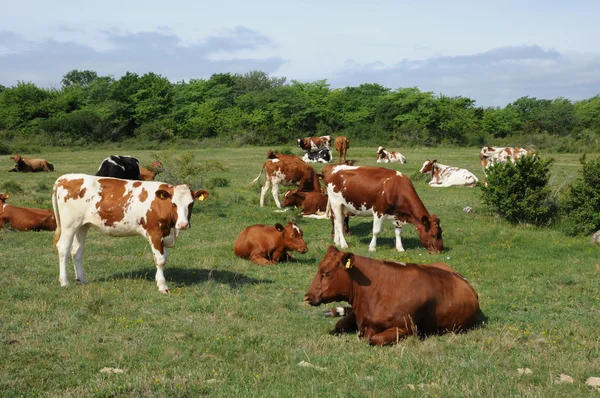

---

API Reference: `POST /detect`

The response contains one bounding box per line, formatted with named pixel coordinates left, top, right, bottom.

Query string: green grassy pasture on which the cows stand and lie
left=0, top=147, right=600, bottom=397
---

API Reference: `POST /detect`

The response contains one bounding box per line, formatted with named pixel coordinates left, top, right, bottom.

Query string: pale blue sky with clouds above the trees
left=0, top=0, right=600, bottom=106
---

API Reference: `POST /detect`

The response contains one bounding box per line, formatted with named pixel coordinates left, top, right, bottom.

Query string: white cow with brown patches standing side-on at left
left=52, top=174, right=209, bottom=293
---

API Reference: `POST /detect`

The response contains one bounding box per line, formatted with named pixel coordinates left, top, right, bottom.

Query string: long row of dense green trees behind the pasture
left=0, top=70, right=600, bottom=152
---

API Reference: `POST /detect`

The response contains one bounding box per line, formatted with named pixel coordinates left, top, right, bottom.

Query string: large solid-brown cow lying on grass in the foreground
left=304, top=246, right=481, bottom=345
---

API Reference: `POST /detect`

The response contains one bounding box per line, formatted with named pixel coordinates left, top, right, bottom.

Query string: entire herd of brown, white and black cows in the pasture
left=0, top=142, right=532, bottom=345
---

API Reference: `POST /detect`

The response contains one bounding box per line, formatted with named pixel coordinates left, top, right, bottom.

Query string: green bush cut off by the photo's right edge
left=561, top=155, right=600, bottom=235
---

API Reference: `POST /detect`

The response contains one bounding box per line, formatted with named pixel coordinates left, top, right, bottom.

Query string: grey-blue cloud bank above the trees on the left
left=0, top=27, right=285, bottom=86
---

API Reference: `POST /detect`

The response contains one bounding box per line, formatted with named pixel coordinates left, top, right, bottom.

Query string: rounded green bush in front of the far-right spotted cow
left=481, top=156, right=557, bottom=225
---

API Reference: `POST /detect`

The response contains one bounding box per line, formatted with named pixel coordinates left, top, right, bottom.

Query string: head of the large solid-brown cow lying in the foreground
left=304, top=245, right=355, bottom=306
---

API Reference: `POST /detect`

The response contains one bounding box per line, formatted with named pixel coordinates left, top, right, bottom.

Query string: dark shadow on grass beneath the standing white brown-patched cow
left=99, top=268, right=273, bottom=289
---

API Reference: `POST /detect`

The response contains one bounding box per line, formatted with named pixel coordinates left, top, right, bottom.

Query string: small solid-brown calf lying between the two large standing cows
left=233, top=222, right=308, bottom=265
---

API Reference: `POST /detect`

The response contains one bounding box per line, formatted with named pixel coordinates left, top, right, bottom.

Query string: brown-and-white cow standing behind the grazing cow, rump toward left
left=250, top=150, right=321, bottom=208
